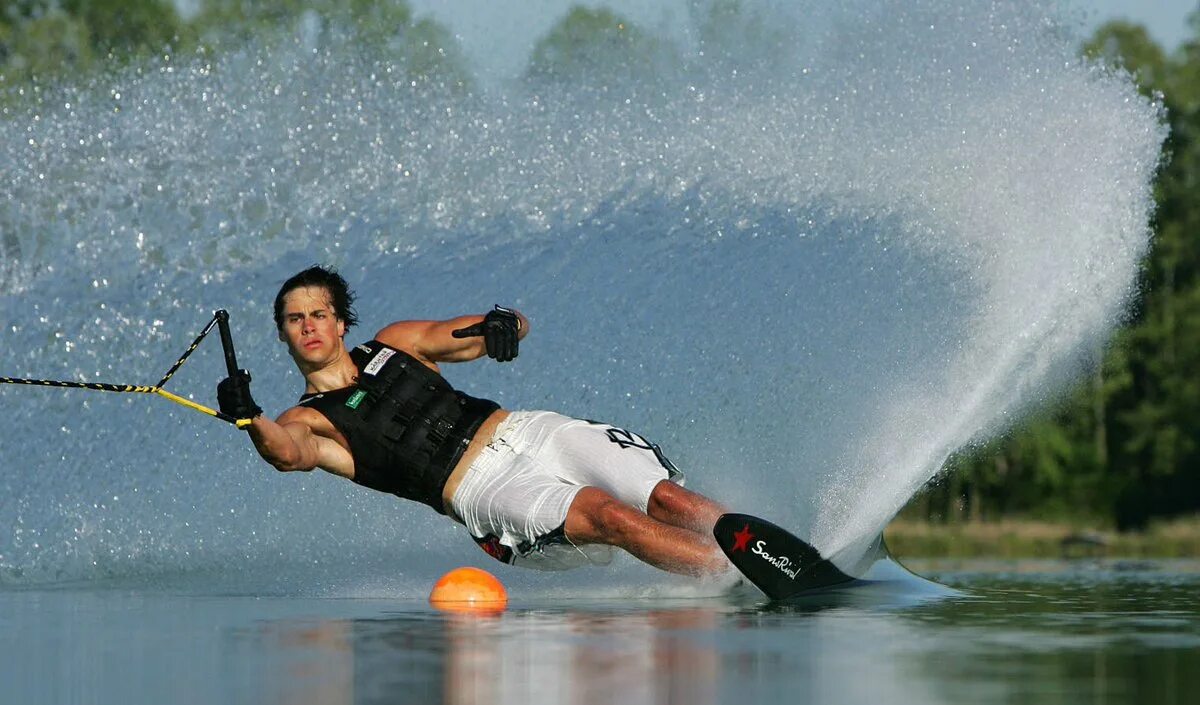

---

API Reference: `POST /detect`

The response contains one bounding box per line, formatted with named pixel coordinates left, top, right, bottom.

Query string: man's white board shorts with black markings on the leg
left=450, top=411, right=683, bottom=570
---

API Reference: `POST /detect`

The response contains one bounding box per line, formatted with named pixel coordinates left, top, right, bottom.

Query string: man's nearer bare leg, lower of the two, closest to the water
left=564, top=487, right=728, bottom=577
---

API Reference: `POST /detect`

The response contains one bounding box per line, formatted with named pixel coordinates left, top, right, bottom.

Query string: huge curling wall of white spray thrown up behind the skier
left=0, top=0, right=1164, bottom=592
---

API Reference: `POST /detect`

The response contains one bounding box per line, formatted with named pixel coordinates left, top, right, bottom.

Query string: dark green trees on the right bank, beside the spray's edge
left=926, top=12, right=1200, bottom=529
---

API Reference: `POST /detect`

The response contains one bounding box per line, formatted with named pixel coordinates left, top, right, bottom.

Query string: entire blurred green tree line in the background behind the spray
left=0, top=0, right=1200, bottom=529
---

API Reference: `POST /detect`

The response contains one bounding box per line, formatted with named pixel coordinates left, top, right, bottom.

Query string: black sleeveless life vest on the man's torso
left=300, top=341, right=500, bottom=514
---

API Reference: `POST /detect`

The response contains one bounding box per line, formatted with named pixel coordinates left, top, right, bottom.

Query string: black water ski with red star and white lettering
left=713, top=514, right=853, bottom=599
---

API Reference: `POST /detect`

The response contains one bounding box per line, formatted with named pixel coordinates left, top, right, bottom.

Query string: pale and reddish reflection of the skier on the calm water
left=253, top=605, right=722, bottom=705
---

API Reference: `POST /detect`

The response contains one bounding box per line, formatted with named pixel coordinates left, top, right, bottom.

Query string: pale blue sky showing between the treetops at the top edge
left=409, top=0, right=1200, bottom=79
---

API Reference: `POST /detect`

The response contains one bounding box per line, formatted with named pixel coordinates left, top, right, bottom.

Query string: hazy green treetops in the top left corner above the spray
left=0, top=0, right=469, bottom=89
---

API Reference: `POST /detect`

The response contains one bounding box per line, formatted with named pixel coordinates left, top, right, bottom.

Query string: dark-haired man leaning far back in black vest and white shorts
left=217, top=267, right=731, bottom=576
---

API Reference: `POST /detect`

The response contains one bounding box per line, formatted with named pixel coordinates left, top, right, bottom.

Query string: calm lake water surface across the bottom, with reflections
left=0, top=561, right=1200, bottom=705
